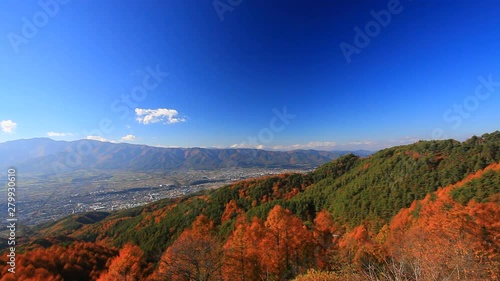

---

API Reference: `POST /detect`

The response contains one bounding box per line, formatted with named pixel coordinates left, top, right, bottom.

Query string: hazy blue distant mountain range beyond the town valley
left=0, top=138, right=365, bottom=174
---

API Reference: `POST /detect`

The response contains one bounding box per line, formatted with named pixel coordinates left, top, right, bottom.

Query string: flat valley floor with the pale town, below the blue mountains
left=0, top=168, right=310, bottom=226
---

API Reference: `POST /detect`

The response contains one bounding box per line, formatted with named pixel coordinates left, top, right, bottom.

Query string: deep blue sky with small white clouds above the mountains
left=0, top=0, right=500, bottom=150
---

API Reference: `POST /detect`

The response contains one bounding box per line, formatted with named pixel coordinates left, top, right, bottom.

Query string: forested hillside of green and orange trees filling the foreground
left=0, top=131, right=500, bottom=280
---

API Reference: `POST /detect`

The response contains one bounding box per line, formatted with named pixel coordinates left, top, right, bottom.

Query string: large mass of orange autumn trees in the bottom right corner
left=378, top=164, right=500, bottom=280
